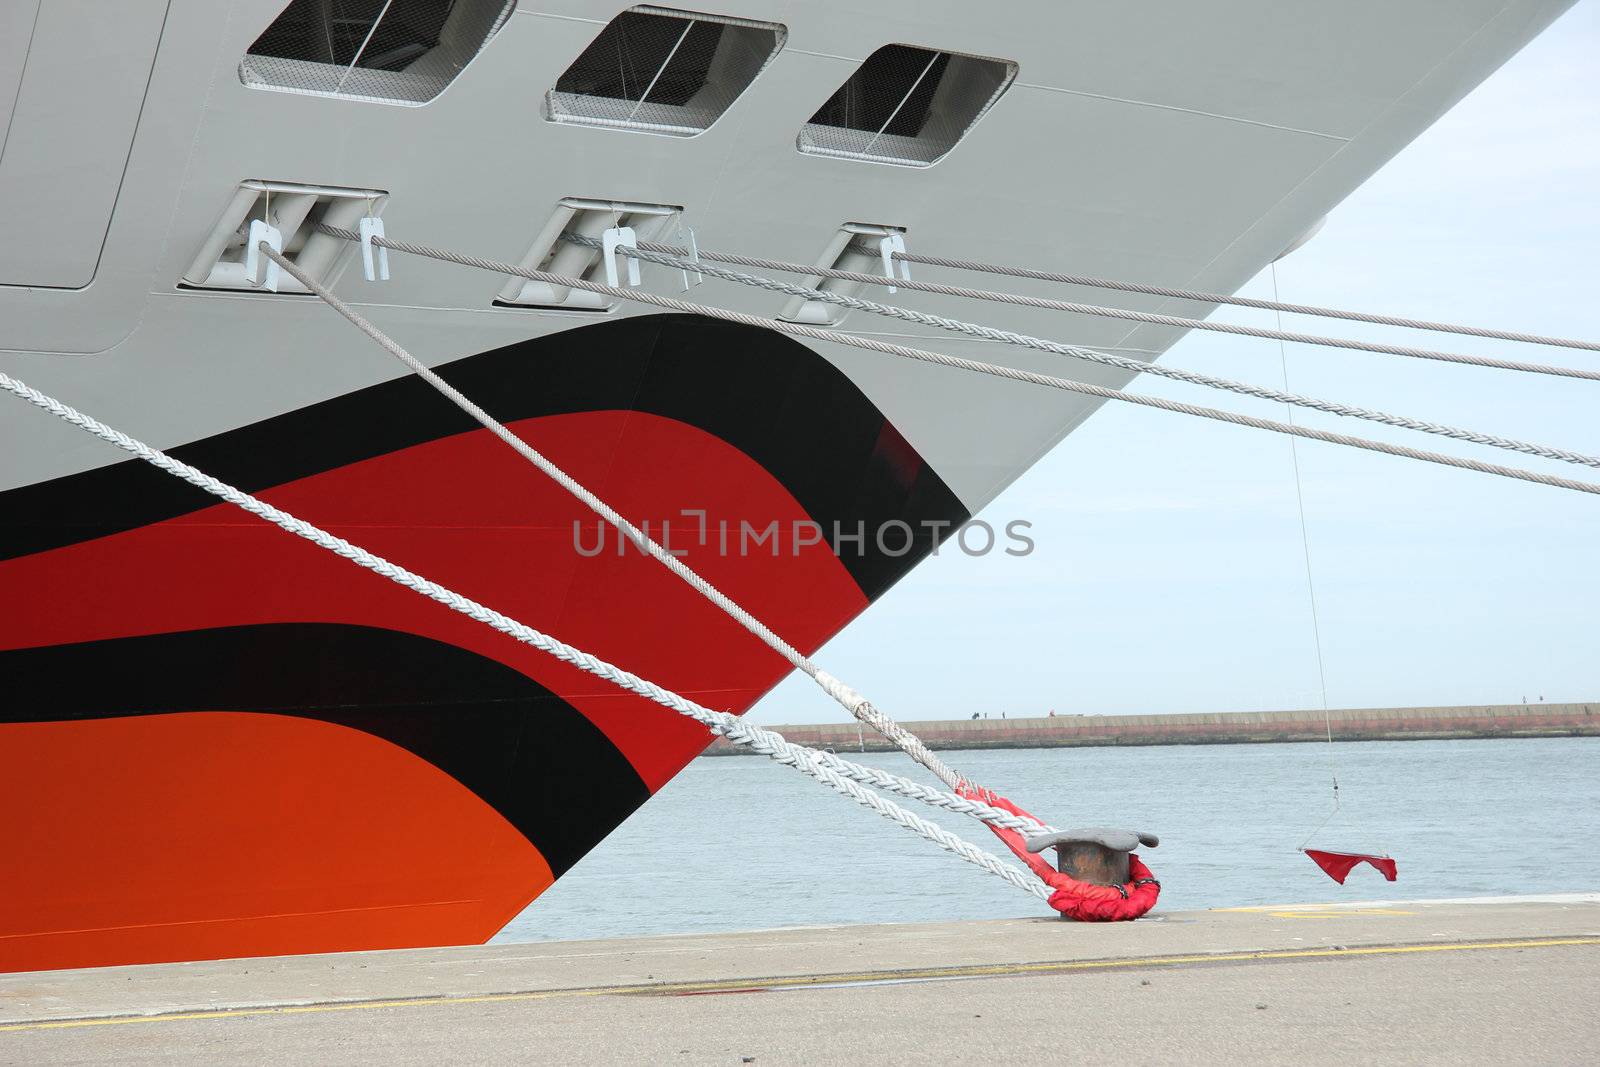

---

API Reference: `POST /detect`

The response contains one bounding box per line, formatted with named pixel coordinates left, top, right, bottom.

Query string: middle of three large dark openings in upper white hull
left=546, top=6, right=789, bottom=138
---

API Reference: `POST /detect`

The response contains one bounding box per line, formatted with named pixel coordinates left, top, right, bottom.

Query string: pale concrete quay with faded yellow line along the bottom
left=0, top=894, right=1600, bottom=1065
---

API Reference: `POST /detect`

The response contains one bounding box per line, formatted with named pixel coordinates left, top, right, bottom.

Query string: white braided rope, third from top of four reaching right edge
left=563, top=234, right=1600, bottom=467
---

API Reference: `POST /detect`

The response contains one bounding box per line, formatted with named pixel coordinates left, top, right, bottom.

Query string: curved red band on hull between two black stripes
left=0, top=411, right=867, bottom=790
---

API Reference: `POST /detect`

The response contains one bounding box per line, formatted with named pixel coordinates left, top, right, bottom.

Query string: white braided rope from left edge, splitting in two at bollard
left=0, top=371, right=1050, bottom=899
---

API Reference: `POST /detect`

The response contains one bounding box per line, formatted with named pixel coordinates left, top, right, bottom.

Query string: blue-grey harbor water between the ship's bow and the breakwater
left=496, top=737, right=1600, bottom=942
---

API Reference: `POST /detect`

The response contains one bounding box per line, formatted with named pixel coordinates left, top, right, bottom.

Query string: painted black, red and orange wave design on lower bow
left=0, top=317, right=965, bottom=969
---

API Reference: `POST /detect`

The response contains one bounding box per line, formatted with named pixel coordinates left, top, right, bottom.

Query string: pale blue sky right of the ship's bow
left=754, top=0, right=1600, bottom=723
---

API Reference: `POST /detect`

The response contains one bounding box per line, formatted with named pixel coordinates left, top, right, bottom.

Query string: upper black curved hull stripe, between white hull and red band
left=0, top=315, right=968, bottom=598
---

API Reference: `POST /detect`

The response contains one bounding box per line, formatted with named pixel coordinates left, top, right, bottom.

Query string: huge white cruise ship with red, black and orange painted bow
left=0, top=0, right=1568, bottom=971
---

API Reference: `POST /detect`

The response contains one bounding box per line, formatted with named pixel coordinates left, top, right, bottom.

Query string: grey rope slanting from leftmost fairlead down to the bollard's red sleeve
left=261, top=244, right=965, bottom=789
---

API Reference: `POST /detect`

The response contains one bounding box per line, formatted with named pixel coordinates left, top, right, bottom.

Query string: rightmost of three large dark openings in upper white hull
left=795, top=45, right=1018, bottom=166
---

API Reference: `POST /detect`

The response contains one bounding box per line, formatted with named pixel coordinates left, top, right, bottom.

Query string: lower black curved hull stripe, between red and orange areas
left=0, top=624, right=649, bottom=875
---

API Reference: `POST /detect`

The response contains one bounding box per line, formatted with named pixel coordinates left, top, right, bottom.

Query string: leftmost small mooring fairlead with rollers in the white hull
left=178, top=181, right=387, bottom=293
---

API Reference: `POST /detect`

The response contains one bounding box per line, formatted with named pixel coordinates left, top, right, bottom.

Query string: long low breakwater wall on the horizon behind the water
left=706, top=701, right=1600, bottom=755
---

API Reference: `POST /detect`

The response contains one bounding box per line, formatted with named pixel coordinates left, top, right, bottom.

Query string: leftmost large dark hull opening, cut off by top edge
left=238, top=0, right=517, bottom=104
